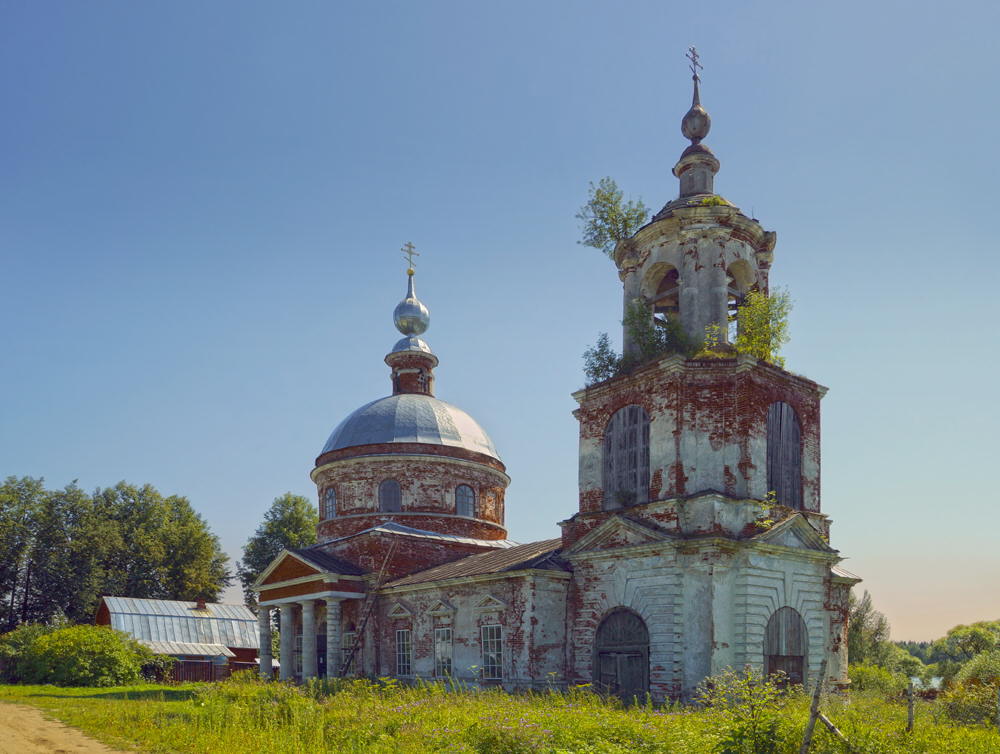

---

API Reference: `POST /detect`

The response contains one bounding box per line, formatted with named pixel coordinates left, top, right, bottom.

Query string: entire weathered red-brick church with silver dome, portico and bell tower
left=254, top=64, right=858, bottom=701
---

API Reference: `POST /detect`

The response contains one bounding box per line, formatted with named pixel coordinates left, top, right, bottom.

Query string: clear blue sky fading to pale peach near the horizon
left=0, top=0, right=1000, bottom=638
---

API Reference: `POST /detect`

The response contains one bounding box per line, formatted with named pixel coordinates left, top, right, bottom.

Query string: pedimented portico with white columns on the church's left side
left=254, top=550, right=365, bottom=681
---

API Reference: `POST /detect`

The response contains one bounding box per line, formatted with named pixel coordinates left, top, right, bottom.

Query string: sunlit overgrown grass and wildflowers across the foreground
left=0, top=677, right=1000, bottom=754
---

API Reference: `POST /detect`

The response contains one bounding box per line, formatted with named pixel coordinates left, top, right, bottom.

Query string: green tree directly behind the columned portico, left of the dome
left=236, top=492, right=319, bottom=607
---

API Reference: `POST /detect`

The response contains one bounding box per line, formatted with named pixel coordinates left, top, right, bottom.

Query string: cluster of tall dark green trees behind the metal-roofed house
left=0, top=476, right=231, bottom=632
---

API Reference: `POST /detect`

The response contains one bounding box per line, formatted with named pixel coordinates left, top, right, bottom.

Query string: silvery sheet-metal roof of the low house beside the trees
left=103, top=597, right=260, bottom=649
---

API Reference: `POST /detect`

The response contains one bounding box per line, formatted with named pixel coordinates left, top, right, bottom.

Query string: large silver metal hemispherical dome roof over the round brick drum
left=320, top=393, right=500, bottom=460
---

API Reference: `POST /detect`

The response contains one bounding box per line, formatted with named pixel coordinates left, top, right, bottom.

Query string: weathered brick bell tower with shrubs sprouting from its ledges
left=561, top=49, right=857, bottom=698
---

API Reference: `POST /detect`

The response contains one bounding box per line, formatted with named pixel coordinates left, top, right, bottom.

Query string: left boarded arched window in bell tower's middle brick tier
left=604, top=406, right=649, bottom=510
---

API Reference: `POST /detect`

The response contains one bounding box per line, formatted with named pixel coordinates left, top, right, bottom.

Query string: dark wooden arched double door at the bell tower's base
left=594, top=608, right=649, bottom=701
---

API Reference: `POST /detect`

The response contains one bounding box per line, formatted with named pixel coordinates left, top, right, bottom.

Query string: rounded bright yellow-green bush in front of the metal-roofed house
left=17, top=626, right=158, bottom=686
